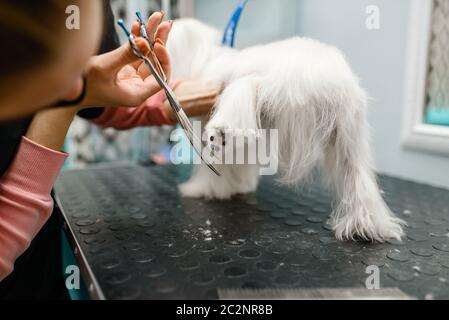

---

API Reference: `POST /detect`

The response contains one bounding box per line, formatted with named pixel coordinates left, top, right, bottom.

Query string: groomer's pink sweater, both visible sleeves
left=0, top=91, right=173, bottom=281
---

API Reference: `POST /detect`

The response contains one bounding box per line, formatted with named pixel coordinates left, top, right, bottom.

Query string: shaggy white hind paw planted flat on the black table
left=332, top=206, right=406, bottom=242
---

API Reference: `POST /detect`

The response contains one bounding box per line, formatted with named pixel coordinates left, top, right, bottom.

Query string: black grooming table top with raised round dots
left=56, top=165, right=449, bottom=299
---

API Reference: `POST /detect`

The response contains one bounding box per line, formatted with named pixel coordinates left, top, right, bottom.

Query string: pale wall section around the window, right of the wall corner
left=298, top=0, right=449, bottom=187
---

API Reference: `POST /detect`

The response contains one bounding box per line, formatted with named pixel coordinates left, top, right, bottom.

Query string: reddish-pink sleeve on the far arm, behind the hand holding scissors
left=92, top=82, right=180, bottom=130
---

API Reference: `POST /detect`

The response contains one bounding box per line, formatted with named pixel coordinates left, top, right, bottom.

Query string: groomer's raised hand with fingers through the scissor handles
left=82, top=12, right=171, bottom=107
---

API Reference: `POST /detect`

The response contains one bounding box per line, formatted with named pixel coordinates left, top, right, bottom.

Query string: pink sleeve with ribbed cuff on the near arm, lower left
left=0, top=137, right=67, bottom=281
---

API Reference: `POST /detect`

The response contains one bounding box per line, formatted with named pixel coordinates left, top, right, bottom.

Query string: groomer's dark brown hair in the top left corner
left=0, top=0, right=76, bottom=77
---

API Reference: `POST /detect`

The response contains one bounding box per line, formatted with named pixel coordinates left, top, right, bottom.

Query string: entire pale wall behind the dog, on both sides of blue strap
left=195, top=0, right=449, bottom=187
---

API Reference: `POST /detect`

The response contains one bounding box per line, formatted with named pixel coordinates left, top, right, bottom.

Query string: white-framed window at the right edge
left=404, top=0, right=449, bottom=156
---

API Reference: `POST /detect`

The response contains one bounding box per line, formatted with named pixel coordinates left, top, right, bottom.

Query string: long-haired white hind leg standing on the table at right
left=324, top=91, right=404, bottom=242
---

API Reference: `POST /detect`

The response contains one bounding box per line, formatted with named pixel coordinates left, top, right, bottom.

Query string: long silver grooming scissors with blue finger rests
left=117, top=16, right=221, bottom=176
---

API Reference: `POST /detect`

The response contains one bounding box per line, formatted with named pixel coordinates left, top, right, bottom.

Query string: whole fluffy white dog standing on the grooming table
left=168, top=19, right=404, bottom=242
